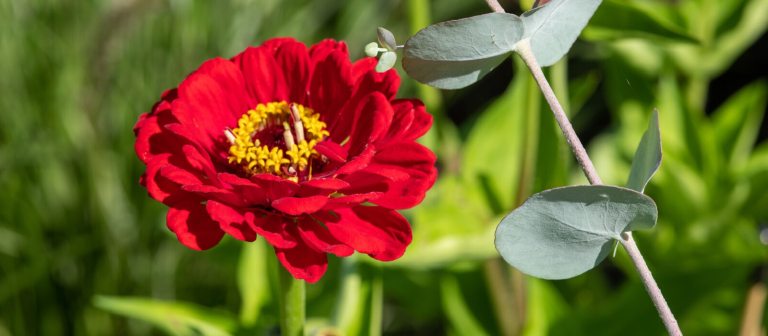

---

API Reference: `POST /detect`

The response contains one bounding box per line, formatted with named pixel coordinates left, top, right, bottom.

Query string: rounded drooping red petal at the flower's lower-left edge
left=166, top=202, right=224, bottom=250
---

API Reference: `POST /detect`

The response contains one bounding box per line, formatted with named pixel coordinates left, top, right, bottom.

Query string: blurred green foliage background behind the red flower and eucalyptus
left=0, top=0, right=768, bottom=335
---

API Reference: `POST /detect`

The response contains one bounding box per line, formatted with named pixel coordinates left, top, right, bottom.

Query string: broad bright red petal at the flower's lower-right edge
left=317, top=206, right=412, bottom=261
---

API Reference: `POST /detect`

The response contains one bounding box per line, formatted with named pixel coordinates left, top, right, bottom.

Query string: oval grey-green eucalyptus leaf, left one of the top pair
left=403, top=13, right=523, bottom=89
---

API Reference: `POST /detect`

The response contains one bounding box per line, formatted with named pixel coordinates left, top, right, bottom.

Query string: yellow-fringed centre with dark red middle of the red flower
left=224, top=101, right=329, bottom=181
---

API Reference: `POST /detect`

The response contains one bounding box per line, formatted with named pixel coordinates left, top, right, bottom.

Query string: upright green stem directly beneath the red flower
left=276, top=263, right=306, bottom=336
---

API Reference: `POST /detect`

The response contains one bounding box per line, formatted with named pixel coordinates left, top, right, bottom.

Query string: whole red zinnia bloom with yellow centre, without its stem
left=134, top=39, right=436, bottom=282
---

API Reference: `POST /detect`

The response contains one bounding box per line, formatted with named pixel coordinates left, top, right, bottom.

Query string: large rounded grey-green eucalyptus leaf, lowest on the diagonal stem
left=495, top=185, right=657, bottom=279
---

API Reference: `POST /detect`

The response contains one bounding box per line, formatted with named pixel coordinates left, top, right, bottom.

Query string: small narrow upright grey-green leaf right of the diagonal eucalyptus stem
left=627, top=110, right=661, bottom=192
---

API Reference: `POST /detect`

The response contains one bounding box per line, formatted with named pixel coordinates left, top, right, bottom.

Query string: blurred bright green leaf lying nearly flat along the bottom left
left=94, top=296, right=236, bottom=336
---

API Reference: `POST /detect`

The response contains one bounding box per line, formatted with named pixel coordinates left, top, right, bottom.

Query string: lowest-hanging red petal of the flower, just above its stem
left=275, top=244, right=328, bottom=283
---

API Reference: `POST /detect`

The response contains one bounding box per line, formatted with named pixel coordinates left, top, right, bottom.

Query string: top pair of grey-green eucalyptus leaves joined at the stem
left=403, top=0, right=601, bottom=89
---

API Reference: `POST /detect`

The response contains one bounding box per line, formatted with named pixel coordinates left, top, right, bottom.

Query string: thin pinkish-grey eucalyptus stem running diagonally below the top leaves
left=516, top=39, right=683, bottom=336
